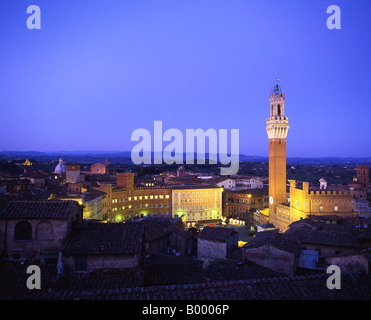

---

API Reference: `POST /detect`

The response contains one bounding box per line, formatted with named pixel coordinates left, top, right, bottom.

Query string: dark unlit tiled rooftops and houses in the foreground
left=0, top=201, right=371, bottom=300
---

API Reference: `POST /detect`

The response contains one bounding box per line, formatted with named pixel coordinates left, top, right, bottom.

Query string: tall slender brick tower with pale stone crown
left=266, top=80, right=289, bottom=227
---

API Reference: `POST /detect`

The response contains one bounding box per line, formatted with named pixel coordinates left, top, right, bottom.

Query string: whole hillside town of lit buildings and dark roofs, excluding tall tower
left=0, top=154, right=371, bottom=300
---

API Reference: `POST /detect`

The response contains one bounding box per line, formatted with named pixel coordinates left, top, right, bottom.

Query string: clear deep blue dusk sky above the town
left=0, top=0, right=371, bottom=157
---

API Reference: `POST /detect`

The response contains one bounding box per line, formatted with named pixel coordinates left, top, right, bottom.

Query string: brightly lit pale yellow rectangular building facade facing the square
left=172, top=186, right=223, bottom=226
